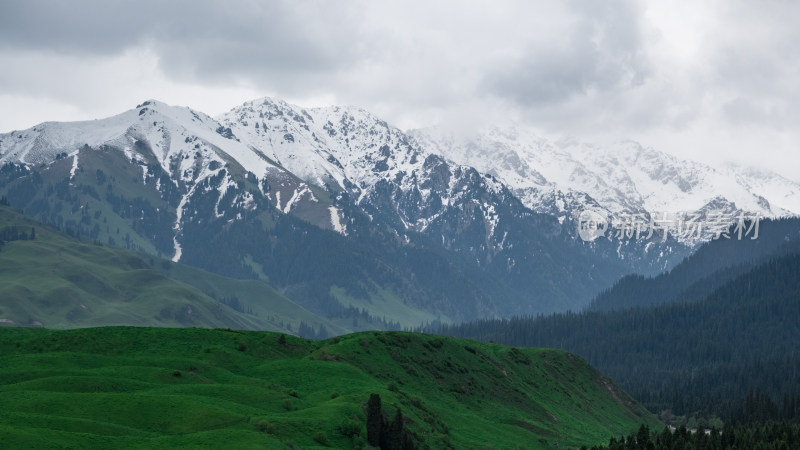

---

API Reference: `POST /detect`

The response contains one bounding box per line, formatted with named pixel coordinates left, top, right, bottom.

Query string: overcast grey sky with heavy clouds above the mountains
left=0, top=0, right=800, bottom=181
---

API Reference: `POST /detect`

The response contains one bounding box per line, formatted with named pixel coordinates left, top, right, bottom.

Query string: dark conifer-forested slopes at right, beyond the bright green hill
left=428, top=253, right=800, bottom=421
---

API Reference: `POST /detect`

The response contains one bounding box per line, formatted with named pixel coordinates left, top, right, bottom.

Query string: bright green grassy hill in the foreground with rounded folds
left=0, top=328, right=656, bottom=448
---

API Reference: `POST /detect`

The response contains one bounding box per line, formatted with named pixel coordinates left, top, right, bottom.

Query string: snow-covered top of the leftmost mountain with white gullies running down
left=0, top=100, right=334, bottom=261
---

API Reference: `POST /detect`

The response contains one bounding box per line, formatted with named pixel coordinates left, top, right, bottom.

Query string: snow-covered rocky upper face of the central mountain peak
left=220, top=99, right=520, bottom=239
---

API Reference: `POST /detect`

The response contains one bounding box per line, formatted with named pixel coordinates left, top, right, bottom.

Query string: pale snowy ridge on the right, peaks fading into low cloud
left=412, top=126, right=800, bottom=239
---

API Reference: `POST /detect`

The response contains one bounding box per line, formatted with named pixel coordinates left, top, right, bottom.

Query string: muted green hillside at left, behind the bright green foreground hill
left=0, top=206, right=346, bottom=332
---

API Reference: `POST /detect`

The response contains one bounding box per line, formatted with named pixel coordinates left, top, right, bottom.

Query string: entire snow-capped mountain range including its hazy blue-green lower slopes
left=0, top=98, right=800, bottom=329
